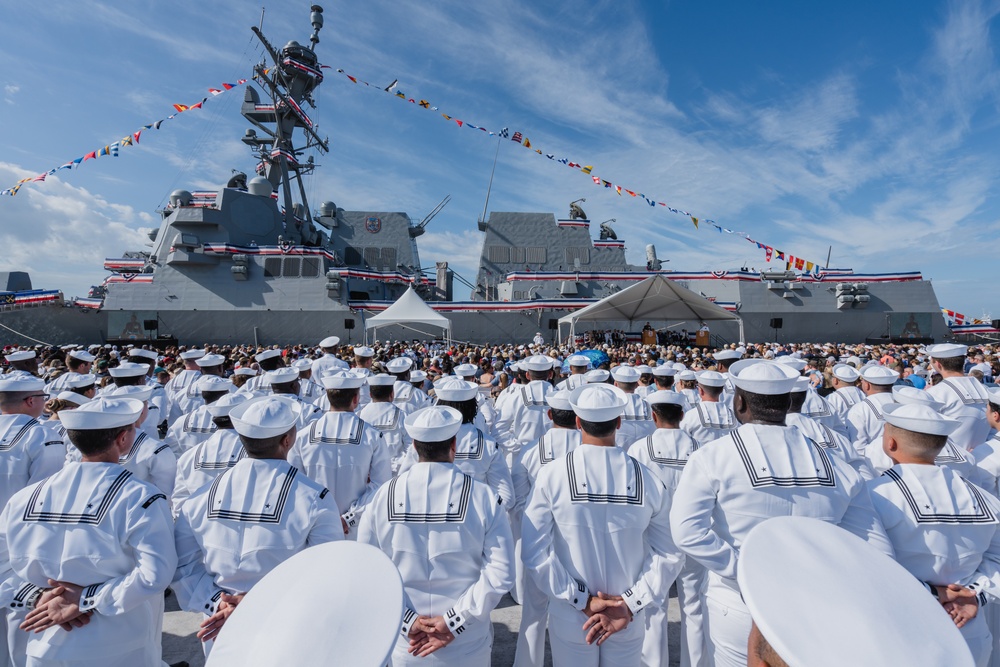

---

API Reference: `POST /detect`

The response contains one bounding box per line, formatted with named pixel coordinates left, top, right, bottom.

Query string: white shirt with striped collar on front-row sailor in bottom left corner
left=0, top=463, right=177, bottom=667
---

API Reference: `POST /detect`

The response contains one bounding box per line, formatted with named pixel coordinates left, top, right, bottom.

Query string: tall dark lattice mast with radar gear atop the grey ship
left=244, top=5, right=329, bottom=241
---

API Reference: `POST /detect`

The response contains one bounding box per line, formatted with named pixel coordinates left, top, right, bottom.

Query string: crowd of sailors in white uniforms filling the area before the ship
left=0, top=336, right=1000, bottom=667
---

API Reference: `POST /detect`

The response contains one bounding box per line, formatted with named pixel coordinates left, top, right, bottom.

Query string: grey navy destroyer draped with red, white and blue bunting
left=0, top=6, right=949, bottom=345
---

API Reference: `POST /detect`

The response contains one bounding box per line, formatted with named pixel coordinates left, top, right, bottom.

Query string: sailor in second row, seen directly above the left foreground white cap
left=288, top=371, right=392, bottom=539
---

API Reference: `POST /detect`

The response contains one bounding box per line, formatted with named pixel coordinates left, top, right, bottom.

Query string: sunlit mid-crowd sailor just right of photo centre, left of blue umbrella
left=496, top=354, right=555, bottom=464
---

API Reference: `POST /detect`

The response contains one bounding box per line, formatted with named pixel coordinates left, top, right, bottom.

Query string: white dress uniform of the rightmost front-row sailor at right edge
left=868, top=464, right=1000, bottom=667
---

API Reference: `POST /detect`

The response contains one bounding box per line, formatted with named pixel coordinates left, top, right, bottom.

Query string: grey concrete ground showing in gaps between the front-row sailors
left=163, top=591, right=681, bottom=667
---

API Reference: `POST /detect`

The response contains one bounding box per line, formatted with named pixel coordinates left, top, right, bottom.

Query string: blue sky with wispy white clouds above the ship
left=0, top=0, right=1000, bottom=317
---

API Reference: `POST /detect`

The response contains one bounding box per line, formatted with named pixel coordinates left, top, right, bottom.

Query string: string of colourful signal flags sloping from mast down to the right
left=337, top=69, right=824, bottom=273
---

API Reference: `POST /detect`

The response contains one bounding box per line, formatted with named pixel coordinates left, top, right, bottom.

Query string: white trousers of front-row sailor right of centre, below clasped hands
left=549, top=600, right=646, bottom=667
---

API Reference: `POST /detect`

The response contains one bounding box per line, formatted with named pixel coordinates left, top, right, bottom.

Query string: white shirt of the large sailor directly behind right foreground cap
left=670, top=424, right=892, bottom=606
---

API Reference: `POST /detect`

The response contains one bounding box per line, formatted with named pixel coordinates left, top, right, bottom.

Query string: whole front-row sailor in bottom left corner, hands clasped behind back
left=0, top=397, right=177, bottom=667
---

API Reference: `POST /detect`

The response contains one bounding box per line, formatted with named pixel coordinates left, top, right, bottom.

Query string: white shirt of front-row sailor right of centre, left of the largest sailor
left=521, top=444, right=684, bottom=614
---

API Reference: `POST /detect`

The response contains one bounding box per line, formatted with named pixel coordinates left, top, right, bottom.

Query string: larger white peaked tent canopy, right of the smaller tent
left=559, top=276, right=743, bottom=342
